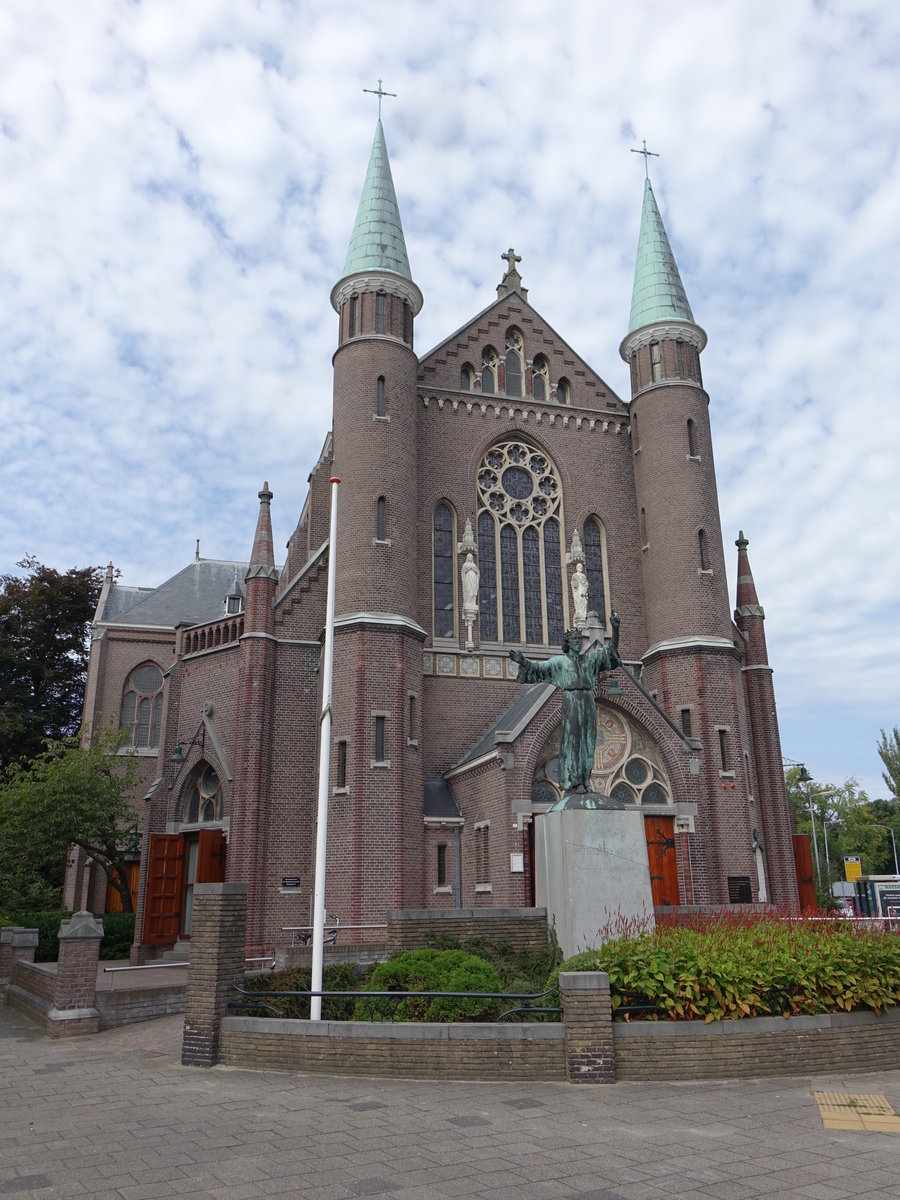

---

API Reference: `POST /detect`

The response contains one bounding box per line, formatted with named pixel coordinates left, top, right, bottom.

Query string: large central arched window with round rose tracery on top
left=478, top=438, right=565, bottom=646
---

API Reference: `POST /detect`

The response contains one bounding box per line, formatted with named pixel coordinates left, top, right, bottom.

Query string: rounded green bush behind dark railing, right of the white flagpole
left=354, top=949, right=503, bottom=1021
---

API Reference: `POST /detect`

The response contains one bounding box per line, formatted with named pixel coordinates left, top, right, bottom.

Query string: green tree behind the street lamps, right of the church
left=785, top=767, right=890, bottom=898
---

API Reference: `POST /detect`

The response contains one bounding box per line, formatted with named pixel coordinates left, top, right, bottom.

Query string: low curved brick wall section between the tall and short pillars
left=218, top=1016, right=565, bottom=1080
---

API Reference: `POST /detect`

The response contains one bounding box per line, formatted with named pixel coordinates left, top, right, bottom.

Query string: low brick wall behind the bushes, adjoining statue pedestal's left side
left=388, top=908, right=548, bottom=954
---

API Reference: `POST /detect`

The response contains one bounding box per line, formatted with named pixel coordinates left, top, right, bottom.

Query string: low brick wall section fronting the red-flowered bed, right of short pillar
left=612, top=1008, right=900, bottom=1081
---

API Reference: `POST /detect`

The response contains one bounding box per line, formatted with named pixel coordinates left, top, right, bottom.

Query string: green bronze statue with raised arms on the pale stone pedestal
left=509, top=612, right=623, bottom=811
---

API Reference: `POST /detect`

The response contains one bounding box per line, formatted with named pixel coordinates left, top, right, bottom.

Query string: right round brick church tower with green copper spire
left=619, top=169, right=790, bottom=904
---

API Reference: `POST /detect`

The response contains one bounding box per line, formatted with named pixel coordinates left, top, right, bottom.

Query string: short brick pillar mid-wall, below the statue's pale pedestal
left=559, top=971, right=616, bottom=1084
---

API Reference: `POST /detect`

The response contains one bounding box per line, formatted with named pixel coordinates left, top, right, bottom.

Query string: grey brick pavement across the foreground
left=0, top=1006, right=900, bottom=1200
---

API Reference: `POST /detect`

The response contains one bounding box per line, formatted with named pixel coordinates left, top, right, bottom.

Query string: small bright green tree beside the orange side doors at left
left=0, top=727, right=138, bottom=912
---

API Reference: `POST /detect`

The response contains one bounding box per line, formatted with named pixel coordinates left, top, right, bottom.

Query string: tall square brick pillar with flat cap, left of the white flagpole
left=181, top=883, right=248, bottom=1067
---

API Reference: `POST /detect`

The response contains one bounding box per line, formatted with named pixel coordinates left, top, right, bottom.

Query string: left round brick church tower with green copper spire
left=325, top=119, right=425, bottom=924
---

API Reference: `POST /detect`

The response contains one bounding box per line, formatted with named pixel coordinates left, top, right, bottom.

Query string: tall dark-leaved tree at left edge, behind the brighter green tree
left=0, top=556, right=103, bottom=770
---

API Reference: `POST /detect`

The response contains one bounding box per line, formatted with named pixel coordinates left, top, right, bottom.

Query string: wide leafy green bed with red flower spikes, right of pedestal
left=548, top=914, right=900, bottom=1021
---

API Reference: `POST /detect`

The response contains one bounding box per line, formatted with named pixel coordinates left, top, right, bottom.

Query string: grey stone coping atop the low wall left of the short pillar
left=222, top=1016, right=565, bottom=1046
